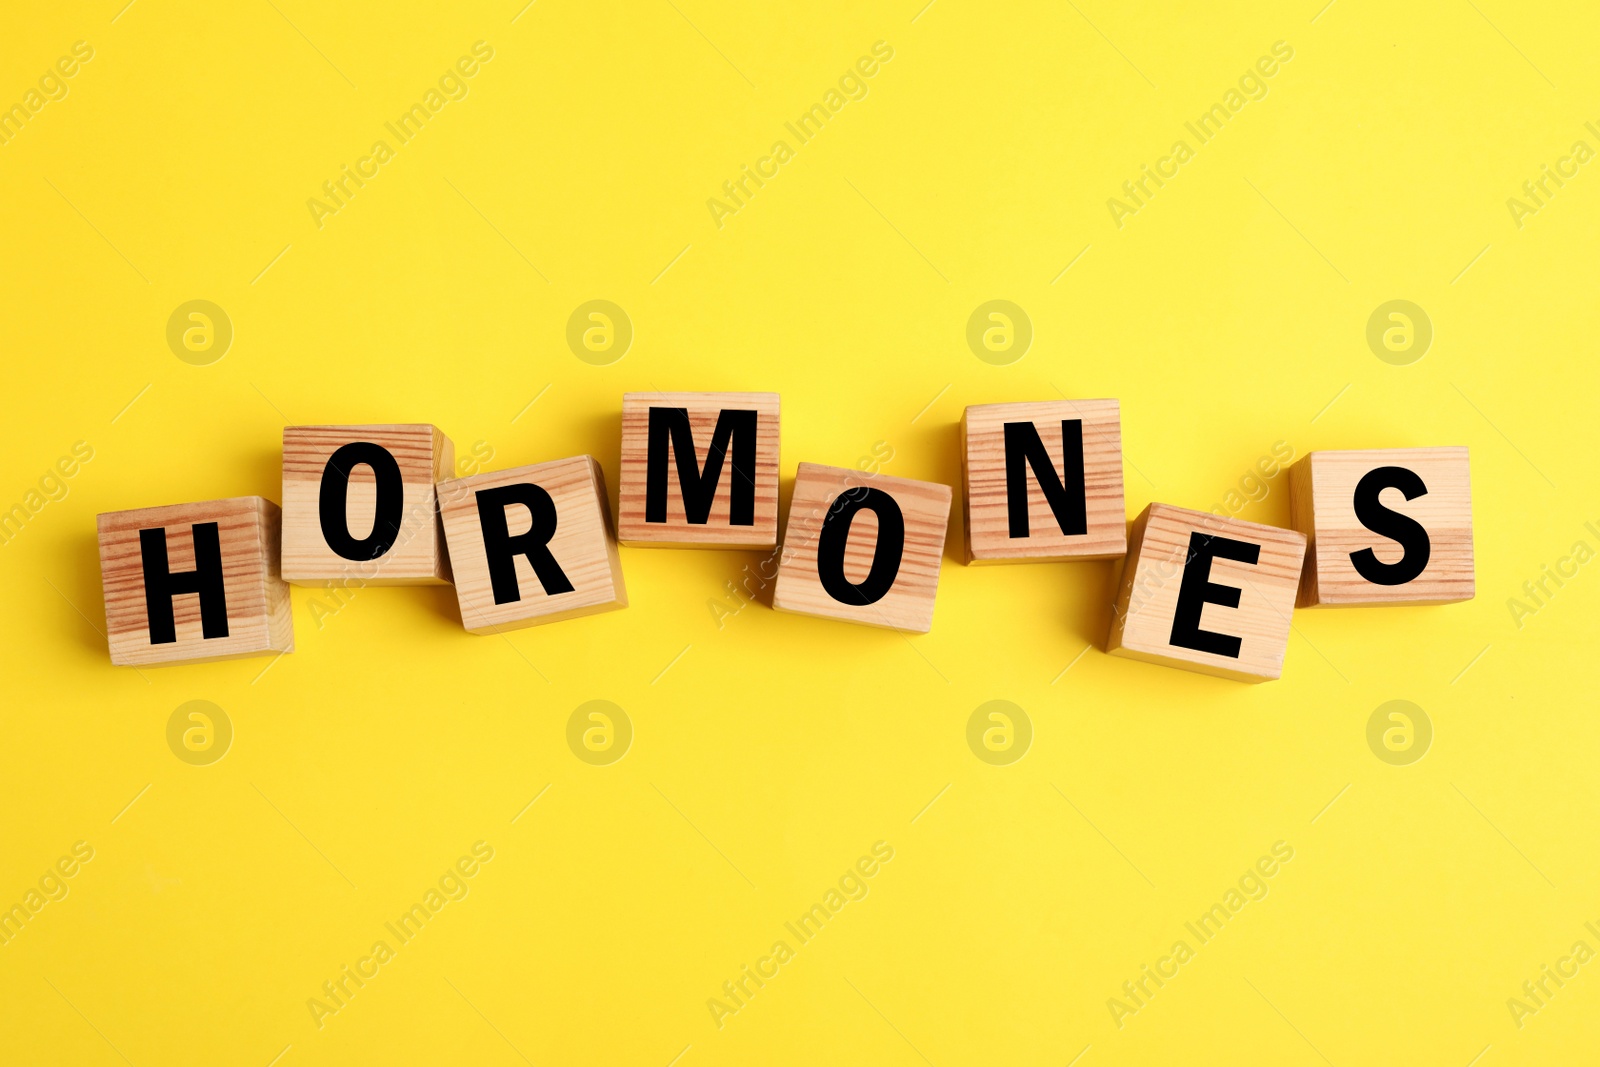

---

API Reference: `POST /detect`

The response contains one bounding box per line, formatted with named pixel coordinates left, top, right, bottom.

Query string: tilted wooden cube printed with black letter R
left=438, top=456, right=627, bottom=633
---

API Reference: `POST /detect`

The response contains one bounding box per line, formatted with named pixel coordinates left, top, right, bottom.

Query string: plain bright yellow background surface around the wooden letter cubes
left=0, top=0, right=1600, bottom=1067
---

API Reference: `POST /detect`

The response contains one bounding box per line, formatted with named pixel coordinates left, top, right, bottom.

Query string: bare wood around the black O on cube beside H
left=283, top=422, right=456, bottom=585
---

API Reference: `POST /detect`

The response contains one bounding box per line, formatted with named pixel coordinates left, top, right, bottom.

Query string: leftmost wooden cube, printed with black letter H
left=96, top=496, right=294, bottom=667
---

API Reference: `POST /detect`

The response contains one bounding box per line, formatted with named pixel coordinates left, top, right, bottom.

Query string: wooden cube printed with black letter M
left=616, top=392, right=778, bottom=549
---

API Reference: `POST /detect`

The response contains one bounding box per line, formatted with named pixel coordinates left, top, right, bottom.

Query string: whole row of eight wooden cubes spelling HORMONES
left=99, top=394, right=1474, bottom=680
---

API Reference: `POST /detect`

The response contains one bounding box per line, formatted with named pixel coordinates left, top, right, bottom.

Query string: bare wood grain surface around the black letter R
left=438, top=456, right=627, bottom=633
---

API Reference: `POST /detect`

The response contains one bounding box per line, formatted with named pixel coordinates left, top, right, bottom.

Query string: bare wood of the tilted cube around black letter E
left=1106, top=504, right=1306, bottom=681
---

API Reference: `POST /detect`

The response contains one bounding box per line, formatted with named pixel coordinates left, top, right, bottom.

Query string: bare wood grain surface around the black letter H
left=96, top=496, right=294, bottom=667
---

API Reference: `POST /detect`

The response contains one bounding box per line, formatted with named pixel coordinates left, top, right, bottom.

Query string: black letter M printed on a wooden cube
left=645, top=408, right=758, bottom=526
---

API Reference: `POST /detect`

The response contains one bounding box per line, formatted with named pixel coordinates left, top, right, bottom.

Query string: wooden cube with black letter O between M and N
left=773, top=464, right=950, bottom=633
